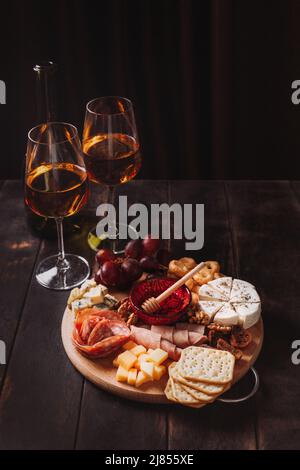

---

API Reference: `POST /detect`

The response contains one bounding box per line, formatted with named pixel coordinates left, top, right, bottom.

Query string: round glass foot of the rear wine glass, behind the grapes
left=87, top=224, right=138, bottom=255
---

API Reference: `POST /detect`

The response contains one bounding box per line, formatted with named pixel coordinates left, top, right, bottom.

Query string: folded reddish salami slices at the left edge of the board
left=72, top=309, right=131, bottom=358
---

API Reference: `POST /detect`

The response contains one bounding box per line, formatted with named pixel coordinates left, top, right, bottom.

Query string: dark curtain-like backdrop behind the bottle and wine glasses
left=0, top=0, right=300, bottom=179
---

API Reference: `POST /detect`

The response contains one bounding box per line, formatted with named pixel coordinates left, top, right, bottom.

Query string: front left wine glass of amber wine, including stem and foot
left=25, top=122, right=90, bottom=290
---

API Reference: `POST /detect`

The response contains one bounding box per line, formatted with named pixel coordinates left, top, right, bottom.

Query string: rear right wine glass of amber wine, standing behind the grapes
left=82, top=96, right=141, bottom=253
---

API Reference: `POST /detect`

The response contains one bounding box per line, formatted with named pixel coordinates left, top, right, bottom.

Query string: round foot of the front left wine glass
left=35, top=254, right=90, bottom=290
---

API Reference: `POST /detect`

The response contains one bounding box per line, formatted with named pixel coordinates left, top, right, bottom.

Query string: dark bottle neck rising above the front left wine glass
left=33, top=62, right=57, bottom=123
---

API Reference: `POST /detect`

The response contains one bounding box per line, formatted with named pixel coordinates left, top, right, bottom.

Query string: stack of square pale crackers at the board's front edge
left=165, top=346, right=235, bottom=408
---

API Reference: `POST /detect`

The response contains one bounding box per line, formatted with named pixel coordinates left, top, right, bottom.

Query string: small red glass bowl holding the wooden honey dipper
left=130, top=277, right=191, bottom=325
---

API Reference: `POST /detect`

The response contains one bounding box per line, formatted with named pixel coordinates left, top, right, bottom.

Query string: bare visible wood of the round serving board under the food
left=61, top=286, right=264, bottom=404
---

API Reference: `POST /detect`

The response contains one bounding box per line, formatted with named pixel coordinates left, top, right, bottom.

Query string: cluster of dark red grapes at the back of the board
left=95, top=235, right=170, bottom=289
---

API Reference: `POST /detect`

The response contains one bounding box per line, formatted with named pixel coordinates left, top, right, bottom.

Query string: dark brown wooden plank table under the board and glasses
left=0, top=180, right=300, bottom=450
